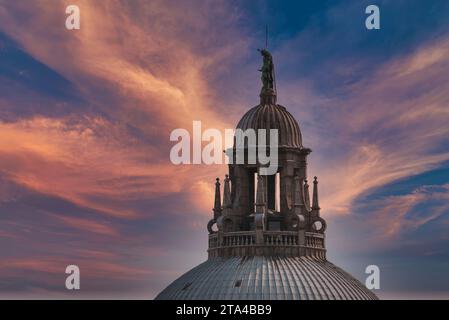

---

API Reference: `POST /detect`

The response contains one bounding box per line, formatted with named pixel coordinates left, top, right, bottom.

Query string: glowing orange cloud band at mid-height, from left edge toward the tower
left=0, top=117, right=224, bottom=218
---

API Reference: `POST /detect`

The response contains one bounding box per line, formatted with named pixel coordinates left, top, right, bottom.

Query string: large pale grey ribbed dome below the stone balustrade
left=156, top=256, right=377, bottom=300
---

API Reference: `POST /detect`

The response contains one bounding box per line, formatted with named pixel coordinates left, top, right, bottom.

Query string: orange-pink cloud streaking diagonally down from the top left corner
left=2, top=1, right=237, bottom=129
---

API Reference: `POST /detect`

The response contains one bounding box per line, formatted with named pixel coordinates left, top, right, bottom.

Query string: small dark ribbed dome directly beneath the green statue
left=237, top=104, right=302, bottom=148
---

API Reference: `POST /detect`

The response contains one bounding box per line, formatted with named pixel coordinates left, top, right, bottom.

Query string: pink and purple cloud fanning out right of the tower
left=300, top=38, right=449, bottom=215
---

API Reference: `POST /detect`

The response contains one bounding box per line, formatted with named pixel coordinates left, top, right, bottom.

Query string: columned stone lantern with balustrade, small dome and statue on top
left=208, top=50, right=326, bottom=259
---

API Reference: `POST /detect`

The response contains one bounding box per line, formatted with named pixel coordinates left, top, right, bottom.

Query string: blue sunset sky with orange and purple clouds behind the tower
left=0, top=0, right=449, bottom=299
